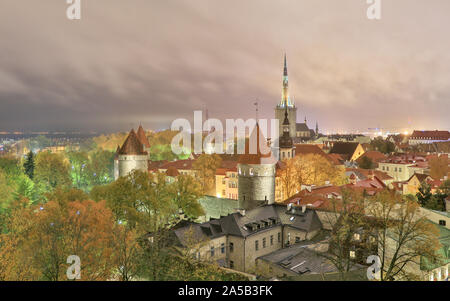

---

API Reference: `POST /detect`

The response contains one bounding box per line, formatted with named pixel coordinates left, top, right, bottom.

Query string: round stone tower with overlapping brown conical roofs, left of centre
left=114, top=126, right=150, bottom=180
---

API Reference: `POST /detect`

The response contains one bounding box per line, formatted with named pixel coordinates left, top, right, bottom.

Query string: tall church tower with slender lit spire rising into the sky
left=275, top=55, right=297, bottom=137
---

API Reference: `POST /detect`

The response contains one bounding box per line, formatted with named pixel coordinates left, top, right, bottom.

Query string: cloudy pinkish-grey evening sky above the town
left=0, top=0, right=450, bottom=132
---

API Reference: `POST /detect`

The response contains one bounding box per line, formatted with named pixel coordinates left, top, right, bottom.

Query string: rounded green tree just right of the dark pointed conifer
left=34, top=152, right=71, bottom=192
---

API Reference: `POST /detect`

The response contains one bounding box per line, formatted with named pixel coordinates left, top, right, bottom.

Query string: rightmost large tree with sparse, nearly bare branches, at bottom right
left=365, top=190, right=440, bottom=281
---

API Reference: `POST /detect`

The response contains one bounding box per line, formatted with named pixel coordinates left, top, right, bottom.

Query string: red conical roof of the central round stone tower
left=238, top=123, right=277, bottom=164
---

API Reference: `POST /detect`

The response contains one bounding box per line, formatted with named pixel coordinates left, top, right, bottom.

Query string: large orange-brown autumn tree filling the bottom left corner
left=0, top=199, right=114, bottom=281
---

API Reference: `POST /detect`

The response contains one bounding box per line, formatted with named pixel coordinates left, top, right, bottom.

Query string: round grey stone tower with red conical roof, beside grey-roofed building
left=238, top=124, right=277, bottom=210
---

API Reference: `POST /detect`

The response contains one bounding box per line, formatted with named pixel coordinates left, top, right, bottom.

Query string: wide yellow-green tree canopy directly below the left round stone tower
left=91, top=170, right=203, bottom=231
